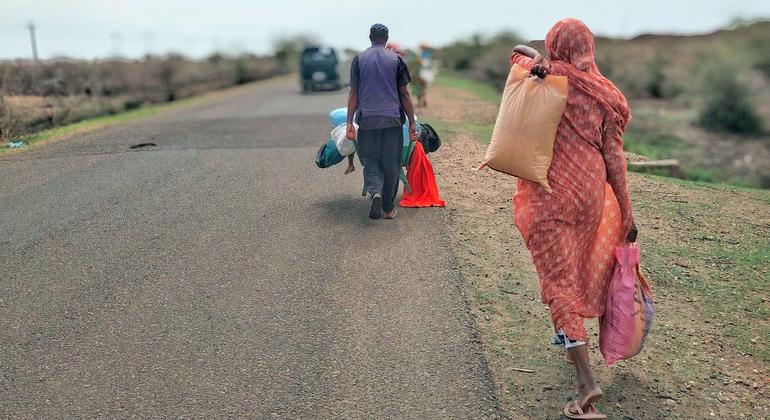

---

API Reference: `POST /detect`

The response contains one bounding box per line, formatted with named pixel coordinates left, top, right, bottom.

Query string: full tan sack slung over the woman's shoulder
left=479, top=64, right=567, bottom=191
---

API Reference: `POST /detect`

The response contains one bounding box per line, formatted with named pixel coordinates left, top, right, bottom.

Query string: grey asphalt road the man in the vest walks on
left=0, top=79, right=497, bottom=418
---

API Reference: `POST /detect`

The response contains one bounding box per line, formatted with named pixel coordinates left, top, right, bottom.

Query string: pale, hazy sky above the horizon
left=0, top=0, right=770, bottom=59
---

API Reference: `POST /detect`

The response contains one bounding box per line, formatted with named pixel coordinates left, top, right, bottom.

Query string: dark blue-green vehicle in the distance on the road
left=299, top=47, right=342, bottom=93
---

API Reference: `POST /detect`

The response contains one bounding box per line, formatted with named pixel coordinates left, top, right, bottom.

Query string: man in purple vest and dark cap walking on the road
left=347, top=24, right=417, bottom=219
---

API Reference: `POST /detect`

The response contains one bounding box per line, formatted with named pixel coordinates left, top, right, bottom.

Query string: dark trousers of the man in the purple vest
left=357, top=127, right=404, bottom=211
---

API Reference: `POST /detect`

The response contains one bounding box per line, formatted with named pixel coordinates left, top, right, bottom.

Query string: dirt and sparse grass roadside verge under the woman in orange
left=419, top=80, right=770, bottom=418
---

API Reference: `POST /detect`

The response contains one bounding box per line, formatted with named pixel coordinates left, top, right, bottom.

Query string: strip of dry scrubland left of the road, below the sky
left=0, top=55, right=284, bottom=142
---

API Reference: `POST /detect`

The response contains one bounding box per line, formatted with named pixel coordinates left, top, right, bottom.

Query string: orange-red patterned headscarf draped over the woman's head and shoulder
left=545, top=18, right=631, bottom=130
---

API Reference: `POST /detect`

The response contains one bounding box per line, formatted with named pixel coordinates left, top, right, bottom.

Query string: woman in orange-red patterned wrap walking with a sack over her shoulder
left=511, top=19, right=636, bottom=419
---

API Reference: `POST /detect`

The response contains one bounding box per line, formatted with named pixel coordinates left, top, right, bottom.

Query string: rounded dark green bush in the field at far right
left=699, top=66, right=762, bottom=134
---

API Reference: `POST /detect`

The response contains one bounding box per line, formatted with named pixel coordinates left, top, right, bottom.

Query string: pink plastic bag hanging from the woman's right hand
left=599, top=244, right=653, bottom=365
